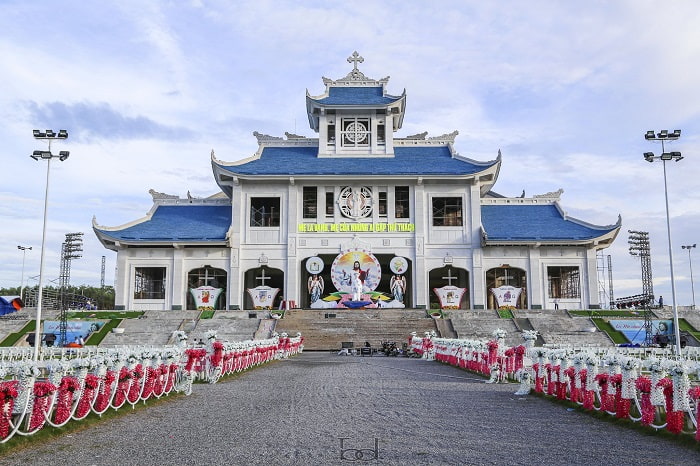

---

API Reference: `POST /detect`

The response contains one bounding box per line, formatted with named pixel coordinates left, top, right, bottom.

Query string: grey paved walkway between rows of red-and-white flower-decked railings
left=0, top=353, right=700, bottom=466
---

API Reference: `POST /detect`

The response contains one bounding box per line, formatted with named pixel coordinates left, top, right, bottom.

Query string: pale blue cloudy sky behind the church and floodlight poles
left=0, top=0, right=700, bottom=305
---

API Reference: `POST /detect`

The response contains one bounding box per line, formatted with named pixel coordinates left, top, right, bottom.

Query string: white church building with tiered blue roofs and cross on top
left=93, top=52, right=621, bottom=310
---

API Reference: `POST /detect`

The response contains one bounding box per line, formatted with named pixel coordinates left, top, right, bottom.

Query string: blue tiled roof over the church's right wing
left=481, top=204, right=616, bottom=241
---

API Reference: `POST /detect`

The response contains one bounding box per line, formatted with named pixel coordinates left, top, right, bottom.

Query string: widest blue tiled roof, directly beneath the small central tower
left=221, top=146, right=498, bottom=176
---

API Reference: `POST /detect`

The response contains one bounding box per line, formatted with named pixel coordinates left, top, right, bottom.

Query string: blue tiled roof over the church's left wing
left=98, top=204, right=231, bottom=242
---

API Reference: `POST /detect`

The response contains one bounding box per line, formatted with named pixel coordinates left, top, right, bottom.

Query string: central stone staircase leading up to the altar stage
left=275, top=309, right=437, bottom=351
